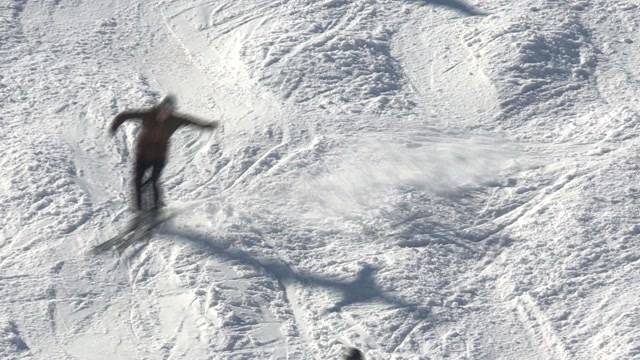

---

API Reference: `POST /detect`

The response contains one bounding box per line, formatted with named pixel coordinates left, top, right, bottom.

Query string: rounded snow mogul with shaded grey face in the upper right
left=464, top=9, right=596, bottom=129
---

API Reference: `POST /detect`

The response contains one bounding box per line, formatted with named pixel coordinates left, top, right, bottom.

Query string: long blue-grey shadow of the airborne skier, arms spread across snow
left=163, top=226, right=429, bottom=314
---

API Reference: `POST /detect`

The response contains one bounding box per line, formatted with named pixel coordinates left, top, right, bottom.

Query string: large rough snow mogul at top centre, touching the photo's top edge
left=243, top=0, right=413, bottom=113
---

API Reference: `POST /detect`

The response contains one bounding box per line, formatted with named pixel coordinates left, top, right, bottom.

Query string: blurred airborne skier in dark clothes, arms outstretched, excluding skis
left=109, top=95, right=218, bottom=212
